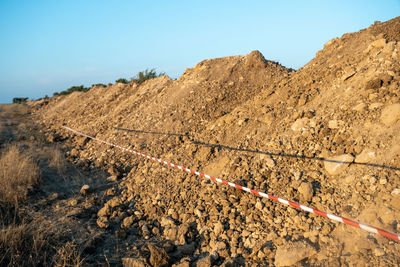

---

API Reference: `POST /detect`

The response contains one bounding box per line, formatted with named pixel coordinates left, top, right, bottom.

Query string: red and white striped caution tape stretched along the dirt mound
left=63, top=126, right=400, bottom=241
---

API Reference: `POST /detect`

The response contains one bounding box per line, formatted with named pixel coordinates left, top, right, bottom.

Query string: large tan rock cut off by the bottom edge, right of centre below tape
left=275, top=241, right=317, bottom=266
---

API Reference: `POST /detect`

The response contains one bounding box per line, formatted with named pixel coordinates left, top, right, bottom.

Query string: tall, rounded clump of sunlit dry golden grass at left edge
left=0, top=145, right=39, bottom=207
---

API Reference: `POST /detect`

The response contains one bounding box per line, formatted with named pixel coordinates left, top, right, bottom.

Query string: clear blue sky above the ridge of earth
left=0, top=0, right=400, bottom=103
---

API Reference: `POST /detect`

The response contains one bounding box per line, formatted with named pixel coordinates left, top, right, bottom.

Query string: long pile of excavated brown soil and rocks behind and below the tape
left=34, top=17, right=400, bottom=266
